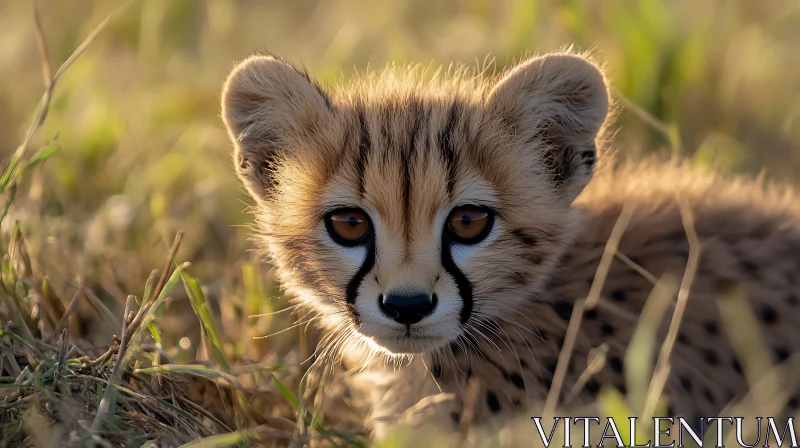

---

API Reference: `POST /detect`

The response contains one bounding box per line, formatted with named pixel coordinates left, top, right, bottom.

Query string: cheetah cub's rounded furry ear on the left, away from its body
left=222, top=56, right=330, bottom=201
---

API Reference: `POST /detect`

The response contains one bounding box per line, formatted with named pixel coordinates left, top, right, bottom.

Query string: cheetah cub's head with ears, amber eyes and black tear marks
left=222, top=50, right=608, bottom=355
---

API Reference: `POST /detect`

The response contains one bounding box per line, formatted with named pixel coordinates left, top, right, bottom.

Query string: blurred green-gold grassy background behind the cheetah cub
left=0, top=0, right=800, bottom=360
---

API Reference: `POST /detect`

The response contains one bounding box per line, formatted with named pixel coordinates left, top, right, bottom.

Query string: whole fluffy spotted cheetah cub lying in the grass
left=222, top=53, right=800, bottom=435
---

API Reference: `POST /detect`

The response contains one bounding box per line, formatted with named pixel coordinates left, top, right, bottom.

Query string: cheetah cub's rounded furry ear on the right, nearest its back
left=486, top=54, right=609, bottom=202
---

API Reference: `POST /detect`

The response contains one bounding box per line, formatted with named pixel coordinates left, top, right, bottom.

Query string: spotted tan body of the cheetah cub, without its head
left=354, top=162, right=800, bottom=436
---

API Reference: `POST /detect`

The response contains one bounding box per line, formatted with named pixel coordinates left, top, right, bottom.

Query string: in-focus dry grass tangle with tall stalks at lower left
left=0, top=5, right=356, bottom=447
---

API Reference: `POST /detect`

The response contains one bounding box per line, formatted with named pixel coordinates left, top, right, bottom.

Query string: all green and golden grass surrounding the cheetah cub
left=0, top=0, right=800, bottom=447
